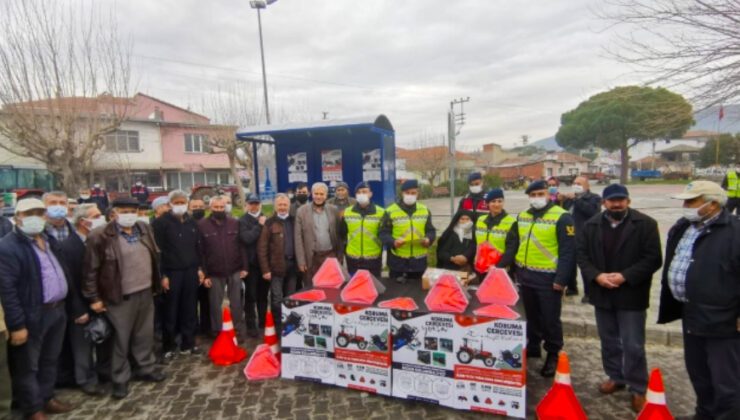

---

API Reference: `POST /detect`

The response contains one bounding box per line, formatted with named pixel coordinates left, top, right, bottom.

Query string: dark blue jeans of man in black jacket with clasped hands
left=595, top=307, right=648, bottom=395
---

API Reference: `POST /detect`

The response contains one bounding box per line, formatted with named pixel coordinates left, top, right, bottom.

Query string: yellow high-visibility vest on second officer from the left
left=386, top=203, right=429, bottom=258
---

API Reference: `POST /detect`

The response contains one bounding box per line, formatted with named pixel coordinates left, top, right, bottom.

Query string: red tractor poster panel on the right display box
left=452, top=315, right=527, bottom=418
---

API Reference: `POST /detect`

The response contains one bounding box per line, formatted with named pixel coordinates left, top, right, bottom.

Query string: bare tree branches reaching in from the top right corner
left=597, top=0, right=740, bottom=107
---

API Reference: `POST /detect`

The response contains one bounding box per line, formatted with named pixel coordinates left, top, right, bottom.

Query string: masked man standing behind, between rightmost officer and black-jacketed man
left=559, top=176, right=601, bottom=303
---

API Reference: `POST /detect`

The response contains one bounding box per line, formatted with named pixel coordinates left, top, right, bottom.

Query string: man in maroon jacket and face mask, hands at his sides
left=198, top=195, right=249, bottom=341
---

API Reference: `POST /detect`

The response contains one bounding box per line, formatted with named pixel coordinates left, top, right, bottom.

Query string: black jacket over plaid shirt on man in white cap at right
left=658, top=210, right=740, bottom=337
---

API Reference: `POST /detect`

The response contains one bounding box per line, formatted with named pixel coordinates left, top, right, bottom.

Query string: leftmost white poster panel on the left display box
left=280, top=298, right=336, bottom=385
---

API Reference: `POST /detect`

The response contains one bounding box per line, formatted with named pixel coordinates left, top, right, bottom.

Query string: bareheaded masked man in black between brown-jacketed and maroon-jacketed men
left=152, top=190, right=205, bottom=360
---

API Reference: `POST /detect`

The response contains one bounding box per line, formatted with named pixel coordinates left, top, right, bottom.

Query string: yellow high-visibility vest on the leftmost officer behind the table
left=344, top=206, right=385, bottom=258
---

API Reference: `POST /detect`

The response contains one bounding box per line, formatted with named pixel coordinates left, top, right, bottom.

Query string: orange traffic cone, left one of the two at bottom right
left=536, top=351, right=587, bottom=420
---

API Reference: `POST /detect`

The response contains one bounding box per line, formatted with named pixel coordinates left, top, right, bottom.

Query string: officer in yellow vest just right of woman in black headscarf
left=475, top=188, right=519, bottom=276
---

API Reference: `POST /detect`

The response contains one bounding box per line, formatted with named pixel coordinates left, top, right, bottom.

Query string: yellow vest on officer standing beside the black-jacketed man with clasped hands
left=516, top=206, right=566, bottom=273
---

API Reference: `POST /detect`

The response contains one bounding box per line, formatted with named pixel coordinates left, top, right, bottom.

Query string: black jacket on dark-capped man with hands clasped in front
left=577, top=209, right=662, bottom=310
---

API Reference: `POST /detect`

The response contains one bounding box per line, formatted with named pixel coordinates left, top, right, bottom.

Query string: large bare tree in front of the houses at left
left=0, top=0, right=131, bottom=193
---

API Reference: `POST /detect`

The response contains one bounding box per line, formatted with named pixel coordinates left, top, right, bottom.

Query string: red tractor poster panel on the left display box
left=333, top=303, right=392, bottom=395
